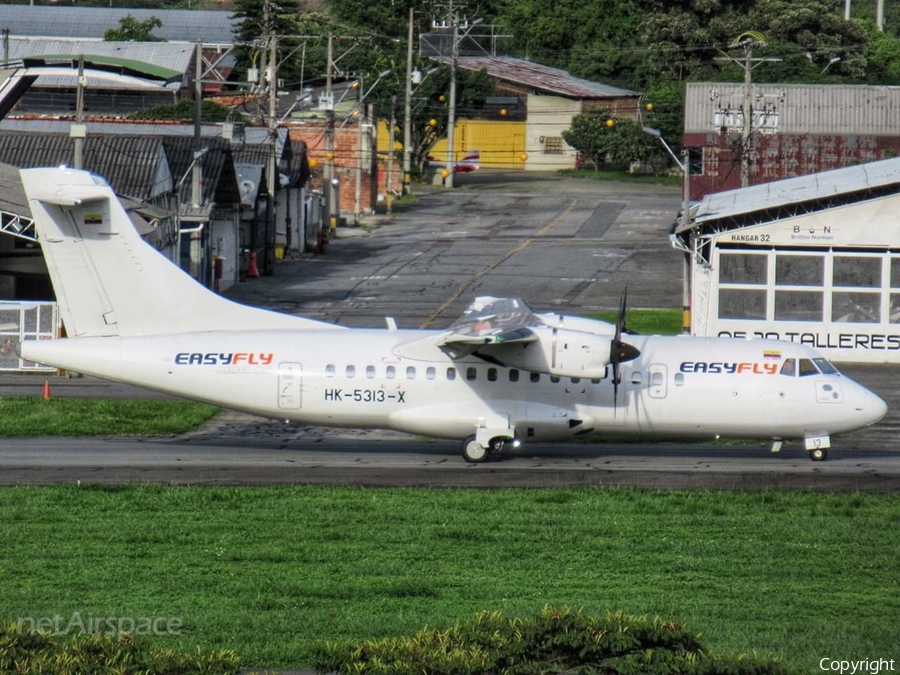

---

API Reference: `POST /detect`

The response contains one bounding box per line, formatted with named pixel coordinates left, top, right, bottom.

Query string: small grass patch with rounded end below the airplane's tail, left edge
left=0, top=397, right=219, bottom=437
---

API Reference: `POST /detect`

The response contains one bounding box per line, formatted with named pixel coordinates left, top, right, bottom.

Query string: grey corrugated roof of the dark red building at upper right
left=684, top=82, right=900, bottom=136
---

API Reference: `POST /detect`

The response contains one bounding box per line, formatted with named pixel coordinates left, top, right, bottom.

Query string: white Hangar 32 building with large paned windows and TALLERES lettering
left=673, top=158, right=900, bottom=363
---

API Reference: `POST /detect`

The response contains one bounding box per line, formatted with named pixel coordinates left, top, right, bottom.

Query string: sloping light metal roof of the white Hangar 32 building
left=676, top=157, right=900, bottom=233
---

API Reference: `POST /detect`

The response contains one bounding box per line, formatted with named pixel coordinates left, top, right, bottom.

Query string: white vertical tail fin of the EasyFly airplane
left=20, top=168, right=338, bottom=337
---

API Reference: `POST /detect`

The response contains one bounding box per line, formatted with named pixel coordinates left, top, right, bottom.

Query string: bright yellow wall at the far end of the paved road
left=378, top=119, right=525, bottom=169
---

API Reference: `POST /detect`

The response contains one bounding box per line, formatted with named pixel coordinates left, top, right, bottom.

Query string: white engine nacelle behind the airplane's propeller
left=501, top=326, right=612, bottom=379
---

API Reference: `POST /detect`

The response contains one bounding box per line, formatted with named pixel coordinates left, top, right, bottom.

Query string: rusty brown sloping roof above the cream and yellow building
left=436, top=56, right=640, bottom=99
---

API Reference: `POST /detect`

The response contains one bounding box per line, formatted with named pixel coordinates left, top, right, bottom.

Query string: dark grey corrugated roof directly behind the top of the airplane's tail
left=0, top=132, right=164, bottom=201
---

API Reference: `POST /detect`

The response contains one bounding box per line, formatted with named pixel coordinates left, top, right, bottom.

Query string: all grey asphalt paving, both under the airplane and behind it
left=0, top=172, right=900, bottom=490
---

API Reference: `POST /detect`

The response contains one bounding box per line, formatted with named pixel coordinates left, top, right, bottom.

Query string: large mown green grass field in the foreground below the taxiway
left=0, top=486, right=900, bottom=672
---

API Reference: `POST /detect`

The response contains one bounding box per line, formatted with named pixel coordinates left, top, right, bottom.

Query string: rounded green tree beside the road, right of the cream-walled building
left=562, top=110, right=660, bottom=170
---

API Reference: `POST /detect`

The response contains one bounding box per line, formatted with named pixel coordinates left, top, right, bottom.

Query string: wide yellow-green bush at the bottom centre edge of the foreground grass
left=314, top=608, right=786, bottom=675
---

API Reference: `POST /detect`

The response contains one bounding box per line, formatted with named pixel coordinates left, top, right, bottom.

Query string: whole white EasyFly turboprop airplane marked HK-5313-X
left=21, top=168, right=887, bottom=462
